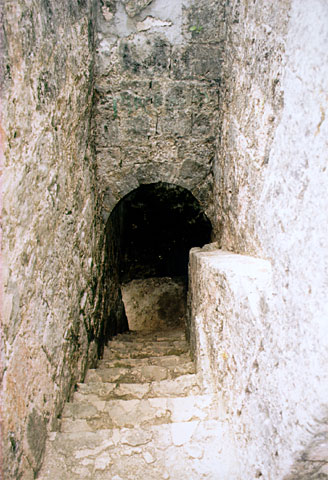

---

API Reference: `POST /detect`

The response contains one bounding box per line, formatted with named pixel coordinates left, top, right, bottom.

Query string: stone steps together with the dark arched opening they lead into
left=39, top=184, right=220, bottom=480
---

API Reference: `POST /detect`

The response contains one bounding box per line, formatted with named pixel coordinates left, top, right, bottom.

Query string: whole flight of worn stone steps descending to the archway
left=38, top=330, right=228, bottom=480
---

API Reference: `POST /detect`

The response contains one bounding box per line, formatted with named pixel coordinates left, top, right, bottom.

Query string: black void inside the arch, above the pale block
left=116, top=183, right=211, bottom=282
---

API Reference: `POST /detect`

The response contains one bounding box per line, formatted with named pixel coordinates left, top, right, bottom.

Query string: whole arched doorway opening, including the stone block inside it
left=103, top=182, right=212, bottom=336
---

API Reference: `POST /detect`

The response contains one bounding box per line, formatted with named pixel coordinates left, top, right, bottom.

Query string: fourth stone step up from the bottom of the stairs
left=85, top=361, right=195, bottom=383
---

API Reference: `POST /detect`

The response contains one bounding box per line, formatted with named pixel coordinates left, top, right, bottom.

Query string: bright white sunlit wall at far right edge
left=254, top=0, right=328, bottom=472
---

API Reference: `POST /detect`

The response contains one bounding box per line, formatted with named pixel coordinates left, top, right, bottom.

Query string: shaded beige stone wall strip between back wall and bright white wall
left=214, top=0, right=290, bottom=246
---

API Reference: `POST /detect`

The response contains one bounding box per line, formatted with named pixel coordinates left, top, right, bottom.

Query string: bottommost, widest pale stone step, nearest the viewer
left=38, top=420, right=233, bottom=480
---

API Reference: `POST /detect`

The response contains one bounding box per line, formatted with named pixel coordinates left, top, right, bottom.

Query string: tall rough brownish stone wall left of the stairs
left=1, top=0, right=104, bottom=479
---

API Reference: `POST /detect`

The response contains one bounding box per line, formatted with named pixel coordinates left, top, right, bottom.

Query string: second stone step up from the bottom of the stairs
left=61, top=394, right=220, bottom=432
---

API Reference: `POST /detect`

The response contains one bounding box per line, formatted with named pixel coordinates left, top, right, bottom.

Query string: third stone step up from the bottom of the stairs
left=74, top=374, right=201, bottom=402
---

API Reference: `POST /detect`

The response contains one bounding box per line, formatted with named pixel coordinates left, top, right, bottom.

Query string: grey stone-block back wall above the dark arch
left=95, top=0, right=224, bottom=218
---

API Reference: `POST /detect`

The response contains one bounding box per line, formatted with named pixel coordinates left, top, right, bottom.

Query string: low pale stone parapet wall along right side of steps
left=189, top=244, right=279, bottom=478
